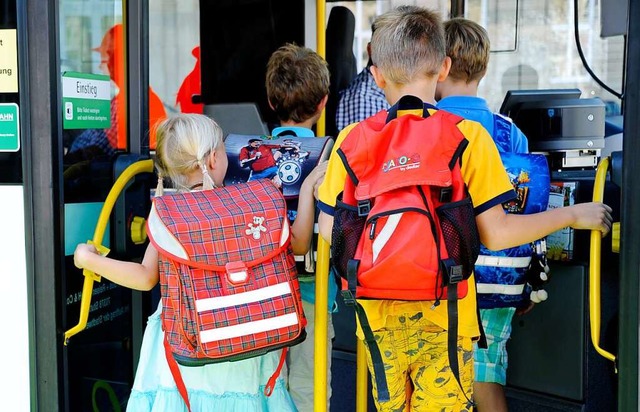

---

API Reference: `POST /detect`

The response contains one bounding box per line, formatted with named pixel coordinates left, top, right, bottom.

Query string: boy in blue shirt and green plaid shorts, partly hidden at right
left=436, top=18, right=529, bottom=412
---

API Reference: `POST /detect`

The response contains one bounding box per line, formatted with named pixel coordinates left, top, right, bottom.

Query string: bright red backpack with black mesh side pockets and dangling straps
left=331, top=96, right=480, bottom=402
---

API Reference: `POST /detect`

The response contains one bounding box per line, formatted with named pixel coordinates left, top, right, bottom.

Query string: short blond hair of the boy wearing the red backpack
left=371, top=6, right=446, bottom=84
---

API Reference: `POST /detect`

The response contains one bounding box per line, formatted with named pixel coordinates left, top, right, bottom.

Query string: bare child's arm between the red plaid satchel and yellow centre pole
left=291, top=162, right=327, bottom=255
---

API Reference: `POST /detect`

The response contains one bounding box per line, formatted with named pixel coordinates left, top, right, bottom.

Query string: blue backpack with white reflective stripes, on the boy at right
left=475, top=115, right=549, bottom=309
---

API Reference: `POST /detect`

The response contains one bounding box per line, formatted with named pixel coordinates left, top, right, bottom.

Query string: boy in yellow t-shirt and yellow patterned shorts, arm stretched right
left=318, top=6, right=611, bottom=412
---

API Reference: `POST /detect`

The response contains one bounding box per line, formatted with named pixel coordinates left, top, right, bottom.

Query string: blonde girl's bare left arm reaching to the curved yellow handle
left=73, top=243, right=159, bottom=290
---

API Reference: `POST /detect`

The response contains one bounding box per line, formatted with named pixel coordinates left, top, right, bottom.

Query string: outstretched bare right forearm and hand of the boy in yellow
left=476, top=202, right=613, bottom=250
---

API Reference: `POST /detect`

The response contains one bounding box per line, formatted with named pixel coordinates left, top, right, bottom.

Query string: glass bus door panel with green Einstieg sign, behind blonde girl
left=59, top=0, right=159, bottom=411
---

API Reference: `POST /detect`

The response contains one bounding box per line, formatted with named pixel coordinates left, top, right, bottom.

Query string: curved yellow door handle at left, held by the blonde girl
left=64, top=159, right=153, bottom=345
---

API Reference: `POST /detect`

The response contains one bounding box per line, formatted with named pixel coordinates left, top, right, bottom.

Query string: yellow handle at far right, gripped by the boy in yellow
left=589, top=157, right=617, bottom=366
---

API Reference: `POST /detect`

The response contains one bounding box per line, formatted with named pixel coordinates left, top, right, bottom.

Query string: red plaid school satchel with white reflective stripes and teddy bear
left=147, top=180, right=306, bottom=406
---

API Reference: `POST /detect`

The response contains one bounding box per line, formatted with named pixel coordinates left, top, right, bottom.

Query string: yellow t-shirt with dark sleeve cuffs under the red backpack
left=318, top=105, right=515, bottom=337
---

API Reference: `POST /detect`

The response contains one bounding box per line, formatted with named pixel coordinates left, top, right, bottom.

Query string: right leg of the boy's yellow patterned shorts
left=408, top=319, right=473, bottom=412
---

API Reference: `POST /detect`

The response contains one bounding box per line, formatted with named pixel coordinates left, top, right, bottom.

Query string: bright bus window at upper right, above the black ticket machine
left=465, top=0, right=624, bottom=114
